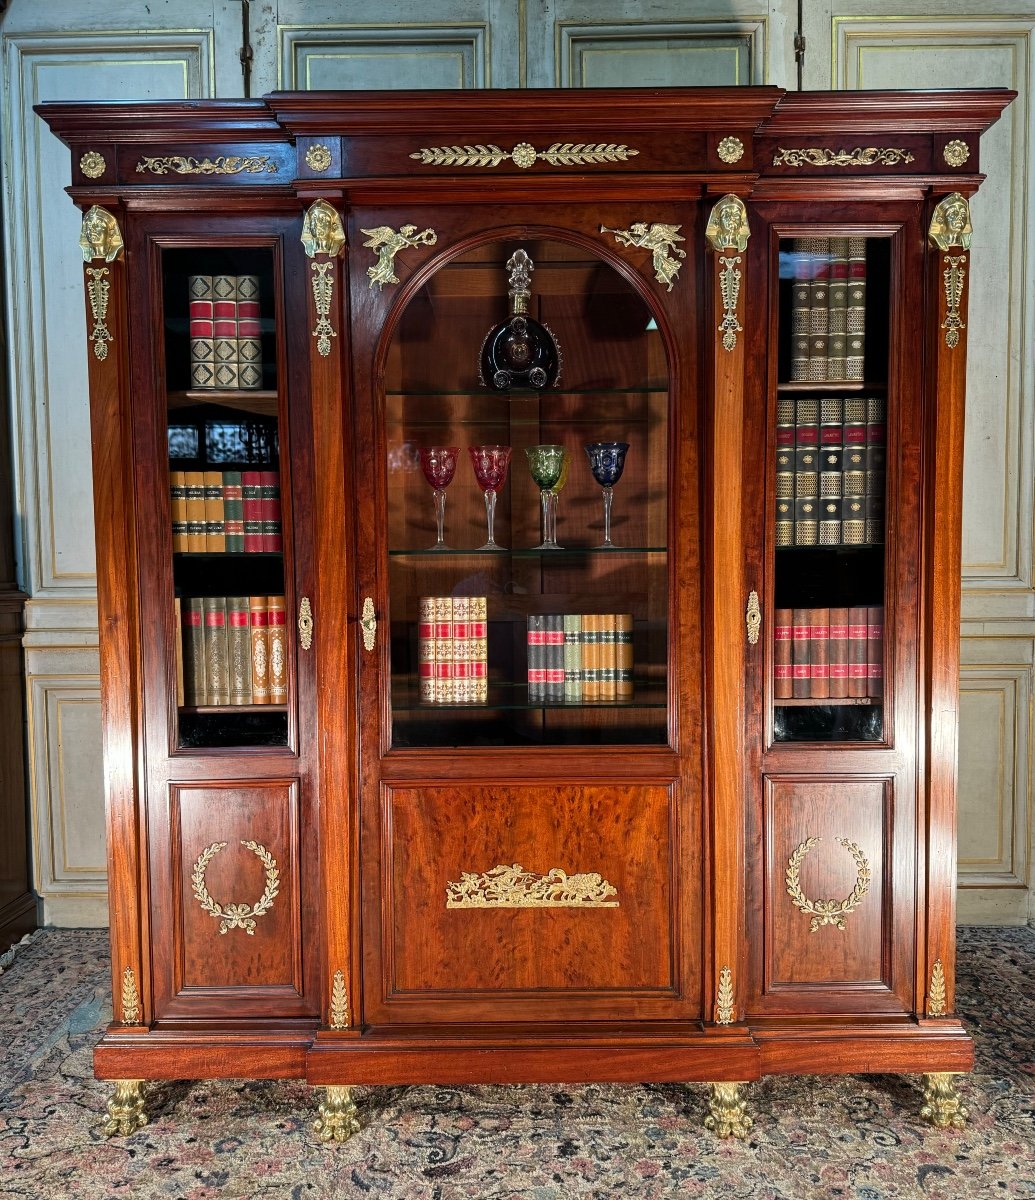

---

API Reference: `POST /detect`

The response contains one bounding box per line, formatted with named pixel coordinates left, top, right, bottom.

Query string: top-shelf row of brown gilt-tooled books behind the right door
left=790, top=238, right=866, bottom=383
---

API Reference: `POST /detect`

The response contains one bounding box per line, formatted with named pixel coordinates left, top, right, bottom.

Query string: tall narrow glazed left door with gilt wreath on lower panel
left=127, top=214, right=317, bottom=1022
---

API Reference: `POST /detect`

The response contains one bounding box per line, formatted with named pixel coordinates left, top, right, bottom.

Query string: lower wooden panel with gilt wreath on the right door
left=766, top=779, right=891, bottom=993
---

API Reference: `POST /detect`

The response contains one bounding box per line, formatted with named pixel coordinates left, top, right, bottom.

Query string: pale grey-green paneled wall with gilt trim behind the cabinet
left=2, top=0, right=1035, bottom=924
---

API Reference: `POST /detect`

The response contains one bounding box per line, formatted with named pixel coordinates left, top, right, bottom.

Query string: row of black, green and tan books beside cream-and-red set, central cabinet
left=528, top=612, right=633, bottom=704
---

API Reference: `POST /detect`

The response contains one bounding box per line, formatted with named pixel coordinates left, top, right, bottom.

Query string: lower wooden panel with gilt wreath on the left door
left=172, top=781, right=303, bottom=994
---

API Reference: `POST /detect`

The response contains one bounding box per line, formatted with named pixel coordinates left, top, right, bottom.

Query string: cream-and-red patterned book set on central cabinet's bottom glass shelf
left=417, top=596, right=489, bottom=704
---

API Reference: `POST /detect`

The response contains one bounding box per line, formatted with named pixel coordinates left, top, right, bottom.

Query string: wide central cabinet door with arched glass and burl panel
left=349, top=200, right=701, bottom=1024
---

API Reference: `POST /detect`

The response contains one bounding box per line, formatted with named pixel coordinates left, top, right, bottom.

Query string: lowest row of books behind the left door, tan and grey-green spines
left=175, top=596, right=287, bottom=707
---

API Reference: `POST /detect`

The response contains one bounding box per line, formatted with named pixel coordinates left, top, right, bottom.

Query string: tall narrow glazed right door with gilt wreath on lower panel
left=747, top=197, right=923, bottom=1015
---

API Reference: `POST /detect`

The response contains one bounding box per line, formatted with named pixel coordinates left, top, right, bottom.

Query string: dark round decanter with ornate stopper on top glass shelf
left=478, top=250, right=561, bottom=391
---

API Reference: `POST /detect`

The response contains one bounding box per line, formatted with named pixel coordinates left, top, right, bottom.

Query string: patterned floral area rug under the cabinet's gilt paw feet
left=0, top=929, right=1035, bottom=1200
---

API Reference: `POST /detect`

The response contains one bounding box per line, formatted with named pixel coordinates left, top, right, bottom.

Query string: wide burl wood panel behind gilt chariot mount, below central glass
left=384, top=786, right=676, bottom=995
